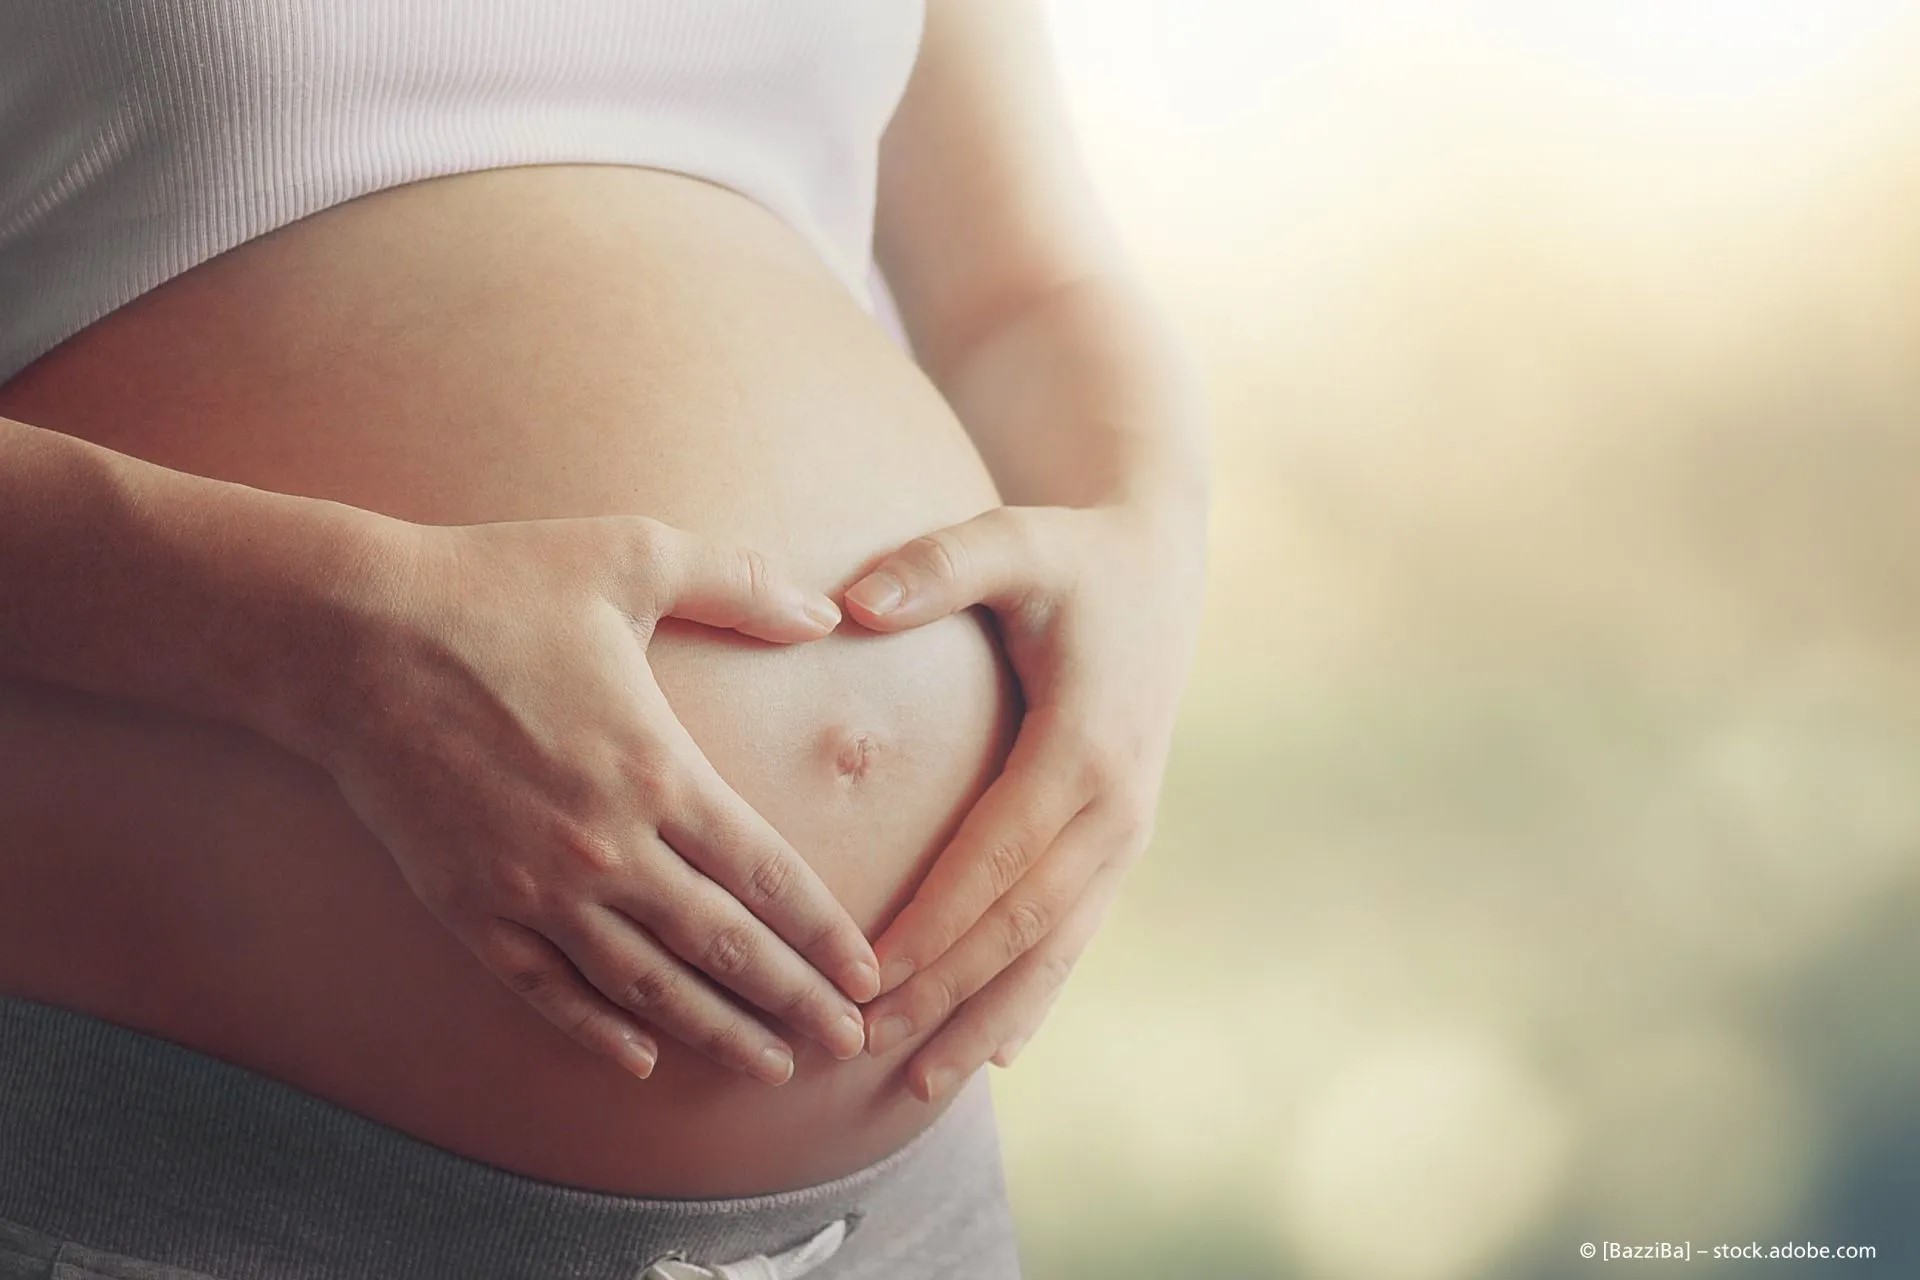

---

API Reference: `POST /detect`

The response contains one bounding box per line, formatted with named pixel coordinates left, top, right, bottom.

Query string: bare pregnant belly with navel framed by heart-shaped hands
left=0, top=167, right=1018, bottom=1196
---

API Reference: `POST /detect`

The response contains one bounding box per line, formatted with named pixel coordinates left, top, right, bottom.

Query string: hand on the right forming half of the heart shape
left=845, top=505, right=1206, bottom=1102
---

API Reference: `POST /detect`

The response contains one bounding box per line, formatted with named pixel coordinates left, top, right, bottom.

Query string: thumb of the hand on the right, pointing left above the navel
left=843, top=507, right=1035, bottom=631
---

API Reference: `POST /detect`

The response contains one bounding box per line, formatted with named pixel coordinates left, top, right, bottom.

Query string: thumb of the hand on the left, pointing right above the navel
left=636, top=516, right=841, bottom=643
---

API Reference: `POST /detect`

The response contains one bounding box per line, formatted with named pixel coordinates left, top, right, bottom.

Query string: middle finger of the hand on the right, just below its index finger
left=866, top=808, right=1125, bottom=1054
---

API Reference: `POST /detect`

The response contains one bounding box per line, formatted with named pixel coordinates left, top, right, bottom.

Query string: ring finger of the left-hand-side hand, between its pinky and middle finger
left=551, top=908, right=793, bottom=1084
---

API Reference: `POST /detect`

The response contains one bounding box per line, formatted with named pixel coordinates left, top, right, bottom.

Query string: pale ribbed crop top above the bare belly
left=0, top=0, right=924, bottom=382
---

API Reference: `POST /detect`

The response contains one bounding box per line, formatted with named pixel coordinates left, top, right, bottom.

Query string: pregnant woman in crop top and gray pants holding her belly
left=0, top=0, right=1206, bottom=1280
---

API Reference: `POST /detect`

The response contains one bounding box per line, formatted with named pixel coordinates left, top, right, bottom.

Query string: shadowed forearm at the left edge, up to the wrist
left=0, top=418, right=405, bottom=752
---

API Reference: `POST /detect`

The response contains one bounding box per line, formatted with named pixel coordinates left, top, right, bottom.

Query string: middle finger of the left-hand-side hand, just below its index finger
left=601, top=850, right=866, bottom=1059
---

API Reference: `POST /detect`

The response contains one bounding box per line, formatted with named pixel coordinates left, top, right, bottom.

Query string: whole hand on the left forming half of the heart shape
left=297, top=516, right=879, bottom=1084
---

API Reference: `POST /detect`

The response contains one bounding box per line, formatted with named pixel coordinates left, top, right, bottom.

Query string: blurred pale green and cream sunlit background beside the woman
left=995, top=0, right=1920, bottom=1280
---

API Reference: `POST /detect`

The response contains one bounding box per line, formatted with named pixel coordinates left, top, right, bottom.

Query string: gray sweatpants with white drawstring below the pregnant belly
left=0, top=994, right=1020, bottom=1280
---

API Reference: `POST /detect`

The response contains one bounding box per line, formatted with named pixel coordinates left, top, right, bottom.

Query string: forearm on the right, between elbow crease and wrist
left=929, top=274, right=1210, bottom=522
